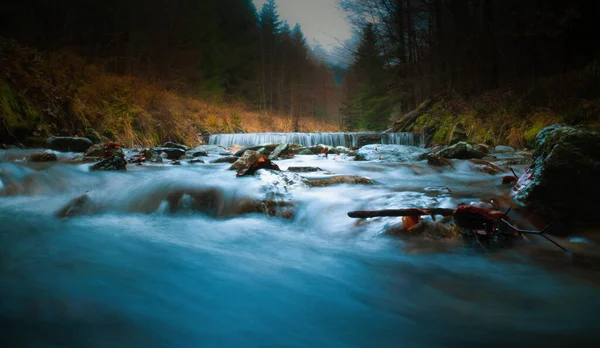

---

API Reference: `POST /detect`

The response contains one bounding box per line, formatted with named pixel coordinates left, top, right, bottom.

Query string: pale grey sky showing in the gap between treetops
left=253, top=0, right=352, bottom=51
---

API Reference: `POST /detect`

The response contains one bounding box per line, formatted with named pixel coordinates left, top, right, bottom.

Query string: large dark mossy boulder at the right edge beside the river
left=514, top=125, right=600, bottom=225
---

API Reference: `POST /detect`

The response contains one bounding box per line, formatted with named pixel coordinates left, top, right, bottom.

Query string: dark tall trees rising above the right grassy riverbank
left=340, top=0, right=600, bottom=128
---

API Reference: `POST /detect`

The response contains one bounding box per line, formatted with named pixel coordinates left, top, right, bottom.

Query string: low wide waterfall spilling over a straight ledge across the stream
left=209, top=132, right=425, bottom=147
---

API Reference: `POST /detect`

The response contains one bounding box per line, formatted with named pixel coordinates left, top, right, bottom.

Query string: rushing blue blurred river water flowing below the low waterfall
left=0, top=147, right=600, bottom=347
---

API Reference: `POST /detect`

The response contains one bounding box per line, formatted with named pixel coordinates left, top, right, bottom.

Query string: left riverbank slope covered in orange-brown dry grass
left=0, top=39, right=337, bottom=147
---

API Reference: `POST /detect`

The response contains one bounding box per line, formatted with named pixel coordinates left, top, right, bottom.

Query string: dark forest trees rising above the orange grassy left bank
left=0, top=0, right=339, bottom=145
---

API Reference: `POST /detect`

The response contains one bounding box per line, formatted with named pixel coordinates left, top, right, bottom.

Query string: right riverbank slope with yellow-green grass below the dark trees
left=391, top=68, right=600, bottom=149
